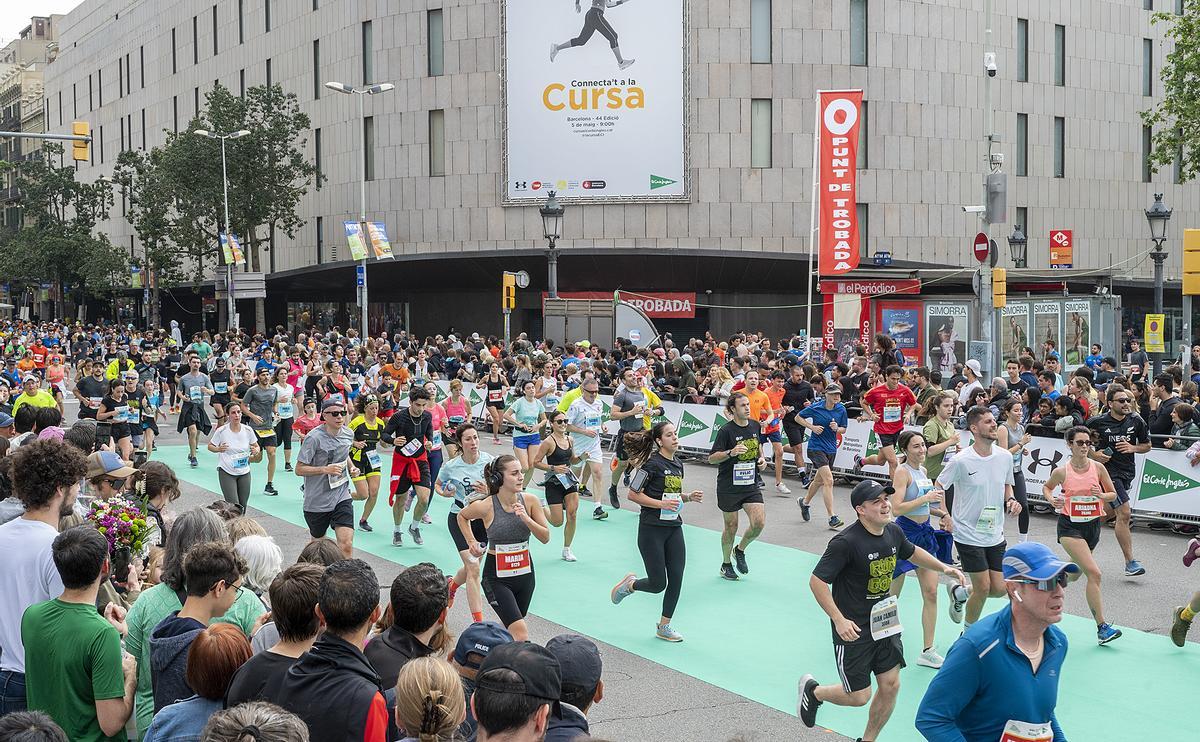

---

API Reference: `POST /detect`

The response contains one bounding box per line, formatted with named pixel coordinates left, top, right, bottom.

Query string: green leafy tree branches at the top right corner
left=1141, top=0, right=1200, bottom=182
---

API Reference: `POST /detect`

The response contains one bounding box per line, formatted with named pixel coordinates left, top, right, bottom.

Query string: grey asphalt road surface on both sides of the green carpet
left=147, top=411, right=1200, bottom=742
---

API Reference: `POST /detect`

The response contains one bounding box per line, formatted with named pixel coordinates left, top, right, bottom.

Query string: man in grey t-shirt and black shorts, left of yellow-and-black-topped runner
left=296, top=399, right=358, bottom=560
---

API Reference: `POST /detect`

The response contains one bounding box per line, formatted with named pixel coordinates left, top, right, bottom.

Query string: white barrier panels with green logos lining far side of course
left=410, top=382, right=1200, bottom=523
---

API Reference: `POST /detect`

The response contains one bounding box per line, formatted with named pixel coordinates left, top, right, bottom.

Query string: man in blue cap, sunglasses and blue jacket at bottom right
left=917, top=541, right=1079, bottom=742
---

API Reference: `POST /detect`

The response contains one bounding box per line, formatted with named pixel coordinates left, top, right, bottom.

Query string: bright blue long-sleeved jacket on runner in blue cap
left=917, top=605, right=1067, bottom=742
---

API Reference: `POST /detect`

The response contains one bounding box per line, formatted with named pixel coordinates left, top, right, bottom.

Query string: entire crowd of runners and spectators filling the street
left=0, top=323, right=1200, bottom=741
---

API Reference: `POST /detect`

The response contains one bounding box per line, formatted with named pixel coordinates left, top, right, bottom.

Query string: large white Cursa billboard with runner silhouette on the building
left=502, top=0, right=688, bottom=204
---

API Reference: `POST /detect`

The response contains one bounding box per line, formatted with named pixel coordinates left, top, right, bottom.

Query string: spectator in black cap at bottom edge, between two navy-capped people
left=470, top=633, right=563, bottom=742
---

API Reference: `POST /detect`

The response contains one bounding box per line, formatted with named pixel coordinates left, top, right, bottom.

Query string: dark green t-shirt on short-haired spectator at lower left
left=20, top=598, right=128, bottom=742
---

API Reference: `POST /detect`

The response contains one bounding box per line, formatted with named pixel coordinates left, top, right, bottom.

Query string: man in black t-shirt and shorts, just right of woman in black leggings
left=708, top=391, right=767, bottom=580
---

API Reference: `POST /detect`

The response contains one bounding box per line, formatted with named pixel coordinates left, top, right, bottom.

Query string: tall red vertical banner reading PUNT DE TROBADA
left=817, top=90, right=863, bottom=276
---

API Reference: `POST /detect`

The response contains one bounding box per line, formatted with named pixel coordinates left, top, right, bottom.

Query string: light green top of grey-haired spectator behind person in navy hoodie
left=125, top=582, right=266, bottom=740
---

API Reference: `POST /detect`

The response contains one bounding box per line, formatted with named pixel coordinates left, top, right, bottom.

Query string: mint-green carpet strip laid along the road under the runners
left=155, top=445, right=1200, bottom=742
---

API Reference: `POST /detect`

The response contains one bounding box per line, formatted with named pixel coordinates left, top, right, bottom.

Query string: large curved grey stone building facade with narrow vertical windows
left=35, top=0, right=1200, bottom=334
